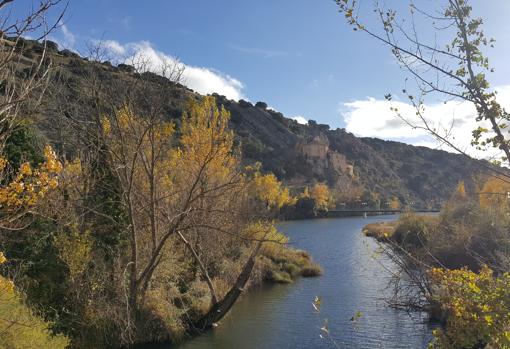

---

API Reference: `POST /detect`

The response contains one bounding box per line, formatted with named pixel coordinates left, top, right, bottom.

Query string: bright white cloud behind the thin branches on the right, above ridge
left=340, top=85, right=510, bottom=158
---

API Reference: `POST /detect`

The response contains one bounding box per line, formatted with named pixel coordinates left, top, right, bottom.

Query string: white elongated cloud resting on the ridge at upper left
left=103, top=40, right=246, bottom=100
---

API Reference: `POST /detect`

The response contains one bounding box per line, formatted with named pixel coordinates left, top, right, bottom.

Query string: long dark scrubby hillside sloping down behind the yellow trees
left=13, top=40, right=486, bottom=208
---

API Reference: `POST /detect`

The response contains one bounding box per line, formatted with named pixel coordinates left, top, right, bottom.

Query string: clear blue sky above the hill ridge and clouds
left=27, top=0, right=510, bottom=152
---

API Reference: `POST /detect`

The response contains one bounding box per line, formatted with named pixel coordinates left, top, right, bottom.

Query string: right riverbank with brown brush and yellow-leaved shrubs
left=363, top=203, right=510, bottom=349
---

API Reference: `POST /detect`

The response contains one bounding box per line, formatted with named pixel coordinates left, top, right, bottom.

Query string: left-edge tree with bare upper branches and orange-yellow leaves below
left=0, top=0, right=65, bottom=230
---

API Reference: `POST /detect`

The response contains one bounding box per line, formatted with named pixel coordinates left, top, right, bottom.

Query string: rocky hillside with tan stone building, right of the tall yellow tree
left=218, top=96, right=482, bottom=208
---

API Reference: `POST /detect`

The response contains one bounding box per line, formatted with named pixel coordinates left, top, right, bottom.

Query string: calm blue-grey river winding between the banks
left=151, top=216, right=431, bottom=349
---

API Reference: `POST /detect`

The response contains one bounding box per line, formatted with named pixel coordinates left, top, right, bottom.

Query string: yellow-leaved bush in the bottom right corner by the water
left=429, top=266, right=510, bottom=349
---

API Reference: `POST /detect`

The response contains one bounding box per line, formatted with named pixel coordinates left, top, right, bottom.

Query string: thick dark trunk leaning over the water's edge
left=191, top=242, right=262, bottom=333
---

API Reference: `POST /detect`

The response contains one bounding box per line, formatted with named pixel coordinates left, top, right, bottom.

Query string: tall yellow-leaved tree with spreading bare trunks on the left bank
left=101, top=97, right=285, bottom=342
